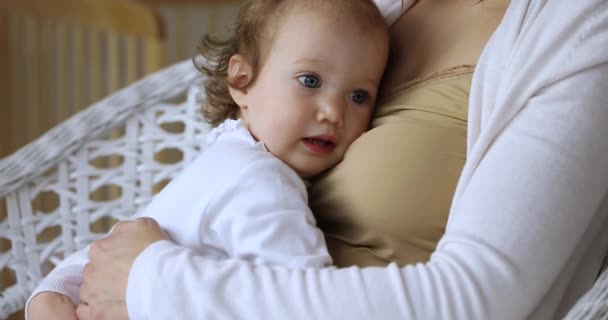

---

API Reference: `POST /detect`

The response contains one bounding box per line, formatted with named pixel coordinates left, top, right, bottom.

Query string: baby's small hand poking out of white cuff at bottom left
left=27, top=291, right=78, bottom=320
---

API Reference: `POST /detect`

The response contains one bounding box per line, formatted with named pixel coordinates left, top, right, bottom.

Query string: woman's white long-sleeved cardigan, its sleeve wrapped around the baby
left=127, top=0, right=608, bottom=320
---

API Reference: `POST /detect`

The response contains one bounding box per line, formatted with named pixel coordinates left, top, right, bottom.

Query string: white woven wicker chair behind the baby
left=0, top=61, right=608, bottom=319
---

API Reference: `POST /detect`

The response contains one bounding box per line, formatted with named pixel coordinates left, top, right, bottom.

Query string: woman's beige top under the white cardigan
left=309, top=67, right=473, bottom=267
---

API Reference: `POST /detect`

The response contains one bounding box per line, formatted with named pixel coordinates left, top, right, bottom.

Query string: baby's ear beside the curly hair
left=226, top=54, right=253, bottom=109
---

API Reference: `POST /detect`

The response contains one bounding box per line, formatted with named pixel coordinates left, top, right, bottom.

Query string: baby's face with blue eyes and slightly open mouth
left=241, top=9, right=388, bottom=177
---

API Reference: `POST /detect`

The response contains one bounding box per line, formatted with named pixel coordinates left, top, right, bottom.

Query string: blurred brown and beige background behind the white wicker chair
left=0, top=0, right=242, bottom=320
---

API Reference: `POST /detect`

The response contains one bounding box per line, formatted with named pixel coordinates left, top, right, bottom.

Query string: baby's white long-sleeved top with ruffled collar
left=28, top=120, right=331, bottom=318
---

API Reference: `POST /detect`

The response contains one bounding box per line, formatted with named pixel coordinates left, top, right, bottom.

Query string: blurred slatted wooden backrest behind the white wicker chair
left=0, top=0, right=165, bottom=157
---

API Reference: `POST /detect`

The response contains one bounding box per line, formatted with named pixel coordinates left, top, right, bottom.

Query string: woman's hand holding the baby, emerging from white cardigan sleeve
left=77, top=218, right=167, bottom=320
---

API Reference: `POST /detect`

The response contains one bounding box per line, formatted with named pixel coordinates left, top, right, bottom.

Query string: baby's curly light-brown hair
left=194, top=0, right=388, bottom=126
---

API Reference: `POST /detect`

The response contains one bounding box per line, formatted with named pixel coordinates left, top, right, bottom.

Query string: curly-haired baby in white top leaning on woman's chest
left=26, top=0, right=389, bottom=320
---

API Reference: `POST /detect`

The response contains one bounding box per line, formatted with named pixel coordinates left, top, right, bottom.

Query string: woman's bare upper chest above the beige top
left=383, top=0, right=509, bottom=92
